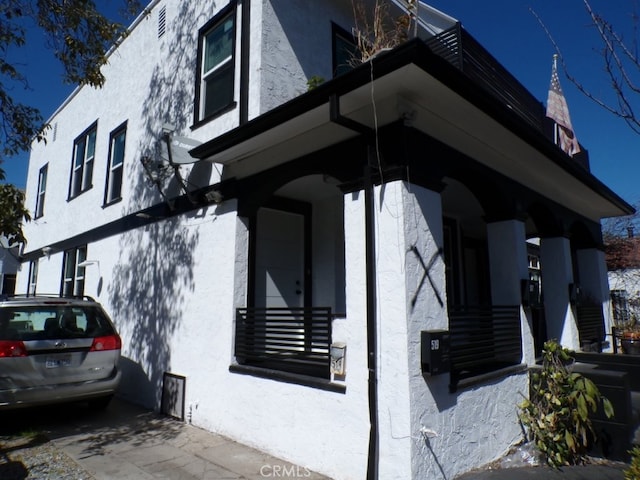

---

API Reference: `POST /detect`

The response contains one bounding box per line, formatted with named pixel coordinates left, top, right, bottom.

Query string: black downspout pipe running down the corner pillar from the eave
left=329, top=95, right=380, bottom=480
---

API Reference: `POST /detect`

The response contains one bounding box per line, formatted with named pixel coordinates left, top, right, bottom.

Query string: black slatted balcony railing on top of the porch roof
left=426, top=23, right=589, bottom=170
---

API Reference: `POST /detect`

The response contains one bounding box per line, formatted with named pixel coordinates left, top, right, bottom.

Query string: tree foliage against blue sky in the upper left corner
left=0, top=0, right=141, bottom=246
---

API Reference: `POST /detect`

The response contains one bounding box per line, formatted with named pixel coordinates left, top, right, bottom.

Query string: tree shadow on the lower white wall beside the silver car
left=109, top=219, right=198, bottom=408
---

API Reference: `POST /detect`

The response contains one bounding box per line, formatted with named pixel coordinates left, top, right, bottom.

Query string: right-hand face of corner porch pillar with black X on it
left=398, top=183, right=448, bottom=479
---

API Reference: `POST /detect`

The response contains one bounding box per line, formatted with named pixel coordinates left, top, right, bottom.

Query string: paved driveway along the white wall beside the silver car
left=46, top=399, right=327, bottom=480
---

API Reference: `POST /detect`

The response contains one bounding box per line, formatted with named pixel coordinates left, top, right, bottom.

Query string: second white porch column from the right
left=540, top=237, right=580, bottom=350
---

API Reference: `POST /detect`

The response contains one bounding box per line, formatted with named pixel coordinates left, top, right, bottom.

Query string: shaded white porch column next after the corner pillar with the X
left=487, top=219, right=535, bottom=364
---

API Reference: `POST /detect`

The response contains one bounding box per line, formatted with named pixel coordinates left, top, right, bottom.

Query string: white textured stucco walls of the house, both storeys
left=20, top=0, right=526, bottom=479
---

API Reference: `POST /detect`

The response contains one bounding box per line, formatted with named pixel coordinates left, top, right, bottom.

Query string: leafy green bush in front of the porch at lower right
left=519, top=340, right=613, bottom=467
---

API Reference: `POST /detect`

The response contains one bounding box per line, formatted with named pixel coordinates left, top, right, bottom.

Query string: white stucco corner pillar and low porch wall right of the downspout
left=376, top=182, right=528, bottom=478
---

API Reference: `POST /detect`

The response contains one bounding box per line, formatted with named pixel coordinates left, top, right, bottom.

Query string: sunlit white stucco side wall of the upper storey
left=25, top=1, right=242, bottom=252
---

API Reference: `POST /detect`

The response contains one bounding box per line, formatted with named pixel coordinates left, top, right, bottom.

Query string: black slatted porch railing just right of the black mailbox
left=449, top=305, right=522, bottom=386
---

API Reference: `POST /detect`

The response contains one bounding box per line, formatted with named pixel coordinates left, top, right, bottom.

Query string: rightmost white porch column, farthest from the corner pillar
left=576, top=248, right=613, bottom=348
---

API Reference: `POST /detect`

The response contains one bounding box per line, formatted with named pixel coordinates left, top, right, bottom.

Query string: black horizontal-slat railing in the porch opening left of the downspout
left=235, top=307, right=333, bottom=378
